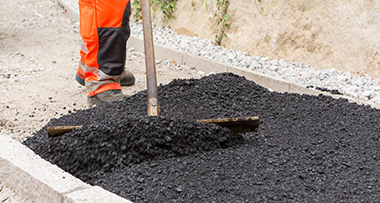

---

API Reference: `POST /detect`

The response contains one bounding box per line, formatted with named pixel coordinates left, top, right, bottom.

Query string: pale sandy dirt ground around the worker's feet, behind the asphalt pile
left=0, top=0, right=200, bottom=141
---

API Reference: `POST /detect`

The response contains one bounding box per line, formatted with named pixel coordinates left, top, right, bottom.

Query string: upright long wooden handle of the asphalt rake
left=141, top=0, right=160, bottom=116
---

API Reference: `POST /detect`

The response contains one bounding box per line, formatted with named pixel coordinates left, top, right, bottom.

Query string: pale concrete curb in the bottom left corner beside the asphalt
left=0, top=135, right=130, bottom=203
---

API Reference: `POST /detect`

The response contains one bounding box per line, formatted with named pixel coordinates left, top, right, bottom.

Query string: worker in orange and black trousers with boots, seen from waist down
left=76, top=0, right=135, bottom=106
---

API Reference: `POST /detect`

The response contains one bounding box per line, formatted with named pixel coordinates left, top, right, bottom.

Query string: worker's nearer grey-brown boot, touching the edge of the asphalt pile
left=87, top=90, right=125, bottom=107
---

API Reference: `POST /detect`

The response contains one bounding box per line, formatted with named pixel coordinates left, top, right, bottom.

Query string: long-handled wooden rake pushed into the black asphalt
left=47, top=0, right=260, bottom=136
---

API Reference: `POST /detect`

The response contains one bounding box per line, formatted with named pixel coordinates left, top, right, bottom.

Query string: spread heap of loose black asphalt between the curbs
left=24, top=73, right=380, bottom=202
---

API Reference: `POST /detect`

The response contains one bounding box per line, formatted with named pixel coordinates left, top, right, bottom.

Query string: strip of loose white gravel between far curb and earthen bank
left=63, top=0, right=380, bottom=104
